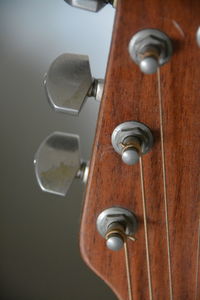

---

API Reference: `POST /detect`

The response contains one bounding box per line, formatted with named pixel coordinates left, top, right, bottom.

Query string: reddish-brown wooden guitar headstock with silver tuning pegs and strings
left=35, top=0, right=200, bottom=300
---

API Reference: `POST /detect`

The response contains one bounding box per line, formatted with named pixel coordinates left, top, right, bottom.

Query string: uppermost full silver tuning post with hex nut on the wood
left=129, top=29, right=172, bottom=74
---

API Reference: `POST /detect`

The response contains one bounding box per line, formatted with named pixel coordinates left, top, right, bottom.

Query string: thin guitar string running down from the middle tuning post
left=139, top=157, right=153, bottom=300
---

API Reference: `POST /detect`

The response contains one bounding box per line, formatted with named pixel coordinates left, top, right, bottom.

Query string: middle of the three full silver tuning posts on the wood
left=111, top=121, right=153, bottom=165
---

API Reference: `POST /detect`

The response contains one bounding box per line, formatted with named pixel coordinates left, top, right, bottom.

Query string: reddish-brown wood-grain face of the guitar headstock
left=80, top=0, right=200, bottom=300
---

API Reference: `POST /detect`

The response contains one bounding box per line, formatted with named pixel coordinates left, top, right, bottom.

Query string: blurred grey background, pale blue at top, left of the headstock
left=0, top=0, right=116, bottom=300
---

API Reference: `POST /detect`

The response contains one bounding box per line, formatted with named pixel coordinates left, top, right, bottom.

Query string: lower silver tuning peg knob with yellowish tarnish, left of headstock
left=34, top=132, right=89, bottom=196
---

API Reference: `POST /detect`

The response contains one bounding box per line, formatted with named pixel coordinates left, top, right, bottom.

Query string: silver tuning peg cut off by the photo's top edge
left=65, top=0, right=117, bottom=12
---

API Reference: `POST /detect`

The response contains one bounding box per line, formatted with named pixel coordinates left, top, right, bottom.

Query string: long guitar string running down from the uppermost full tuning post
left=157, top=68, right=173, bottom=300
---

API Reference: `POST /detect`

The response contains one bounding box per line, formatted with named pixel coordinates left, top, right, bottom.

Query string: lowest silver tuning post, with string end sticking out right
left=97, top=207, right=138, bottom=251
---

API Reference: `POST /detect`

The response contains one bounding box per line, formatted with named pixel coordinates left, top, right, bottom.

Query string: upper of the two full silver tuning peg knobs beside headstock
left=44, top=53, right=104, bottom=115
